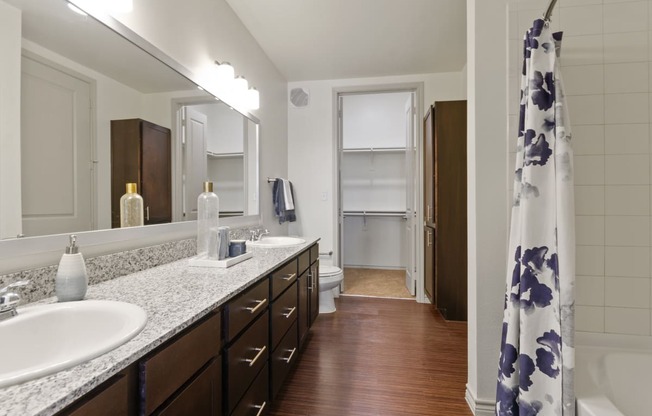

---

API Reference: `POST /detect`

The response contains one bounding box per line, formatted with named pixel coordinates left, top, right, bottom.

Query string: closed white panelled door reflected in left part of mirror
left=20, top=56, right=95, bottom=236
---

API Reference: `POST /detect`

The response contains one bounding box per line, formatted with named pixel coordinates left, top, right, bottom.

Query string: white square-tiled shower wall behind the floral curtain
left=507, top=0, right=652, bottom=336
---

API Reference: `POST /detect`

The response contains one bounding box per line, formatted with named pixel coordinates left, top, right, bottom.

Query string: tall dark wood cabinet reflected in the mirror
left=111, top=118, right=172, bottom=228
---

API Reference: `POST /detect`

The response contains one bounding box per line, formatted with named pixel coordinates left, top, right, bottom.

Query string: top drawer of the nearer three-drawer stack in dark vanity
left=226, top=279, right=269, bottom=342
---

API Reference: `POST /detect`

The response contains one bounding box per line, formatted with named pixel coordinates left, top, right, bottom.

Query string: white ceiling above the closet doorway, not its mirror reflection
left=226, top=0, right=466, bottom=81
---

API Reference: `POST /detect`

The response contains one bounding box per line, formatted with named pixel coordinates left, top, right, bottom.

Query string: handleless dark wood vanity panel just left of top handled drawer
left=140, top=312, right=221, bottom=415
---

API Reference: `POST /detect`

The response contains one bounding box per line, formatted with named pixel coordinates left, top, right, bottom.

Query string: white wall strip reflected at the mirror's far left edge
left=0, top=1, right=22, bottom=239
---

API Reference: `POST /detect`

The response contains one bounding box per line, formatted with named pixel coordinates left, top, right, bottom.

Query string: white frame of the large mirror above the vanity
left=0, top=0, right=262, bottom=275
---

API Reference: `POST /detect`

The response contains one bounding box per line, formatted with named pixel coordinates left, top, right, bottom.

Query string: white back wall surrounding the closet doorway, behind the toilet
left=286, top=72, right=466, bottom=260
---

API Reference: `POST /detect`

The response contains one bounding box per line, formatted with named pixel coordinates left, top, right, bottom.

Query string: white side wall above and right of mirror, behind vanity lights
left=117, top=0, right=288, bottom=234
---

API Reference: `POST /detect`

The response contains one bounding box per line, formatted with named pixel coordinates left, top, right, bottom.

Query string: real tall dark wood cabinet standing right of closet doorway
left=423, top=101, right=467, bottom=321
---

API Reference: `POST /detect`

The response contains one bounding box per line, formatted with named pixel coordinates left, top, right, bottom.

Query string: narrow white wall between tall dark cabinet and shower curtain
left=466, top=0, right=507, bottom=416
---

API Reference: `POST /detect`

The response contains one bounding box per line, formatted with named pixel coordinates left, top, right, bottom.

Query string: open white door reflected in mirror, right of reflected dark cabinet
left=181, top=107, right=207, bottom=221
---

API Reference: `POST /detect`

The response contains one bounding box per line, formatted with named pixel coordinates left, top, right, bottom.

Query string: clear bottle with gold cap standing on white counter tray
left=197, top=182, right=220, bottom=260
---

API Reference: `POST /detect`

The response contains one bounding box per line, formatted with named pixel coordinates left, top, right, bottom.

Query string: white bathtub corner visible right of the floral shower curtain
left=575, top=333, right=652, bottom=416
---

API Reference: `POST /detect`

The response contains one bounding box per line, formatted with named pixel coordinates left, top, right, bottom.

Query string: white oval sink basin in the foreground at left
left=0, top=300, right=147, bottom=387
